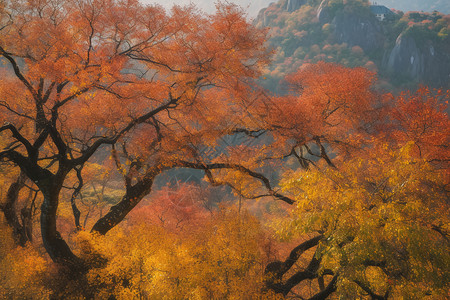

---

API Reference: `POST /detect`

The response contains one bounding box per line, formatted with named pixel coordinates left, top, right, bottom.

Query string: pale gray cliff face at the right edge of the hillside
left=383, top=35, right=450, bottom=87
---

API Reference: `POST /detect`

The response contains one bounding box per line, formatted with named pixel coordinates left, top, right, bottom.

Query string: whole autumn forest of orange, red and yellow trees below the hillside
left=0, top=0, right=450, bottom=300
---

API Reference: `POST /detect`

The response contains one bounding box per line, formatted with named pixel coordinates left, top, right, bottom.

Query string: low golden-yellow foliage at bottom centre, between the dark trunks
left=66, top=209, right=270, bottom=299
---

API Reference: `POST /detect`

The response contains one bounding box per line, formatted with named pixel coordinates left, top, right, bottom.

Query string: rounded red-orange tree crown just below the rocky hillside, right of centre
left=260, top=62, right=382, bottom=169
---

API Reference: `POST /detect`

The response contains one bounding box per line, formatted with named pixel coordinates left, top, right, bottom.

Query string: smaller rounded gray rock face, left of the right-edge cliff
left=332, top=12, right=384, bottom=52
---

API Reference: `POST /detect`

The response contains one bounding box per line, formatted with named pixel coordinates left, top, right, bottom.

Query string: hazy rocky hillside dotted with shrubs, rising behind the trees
left=255, top=0, right=450, bottom=91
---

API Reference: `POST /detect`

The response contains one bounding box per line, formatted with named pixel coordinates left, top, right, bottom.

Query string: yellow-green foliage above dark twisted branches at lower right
left=282, top=143, right=450, bottom=299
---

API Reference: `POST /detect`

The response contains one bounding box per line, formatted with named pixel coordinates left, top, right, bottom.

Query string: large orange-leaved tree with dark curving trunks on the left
left=0, top=0, right=268, bottom=269
